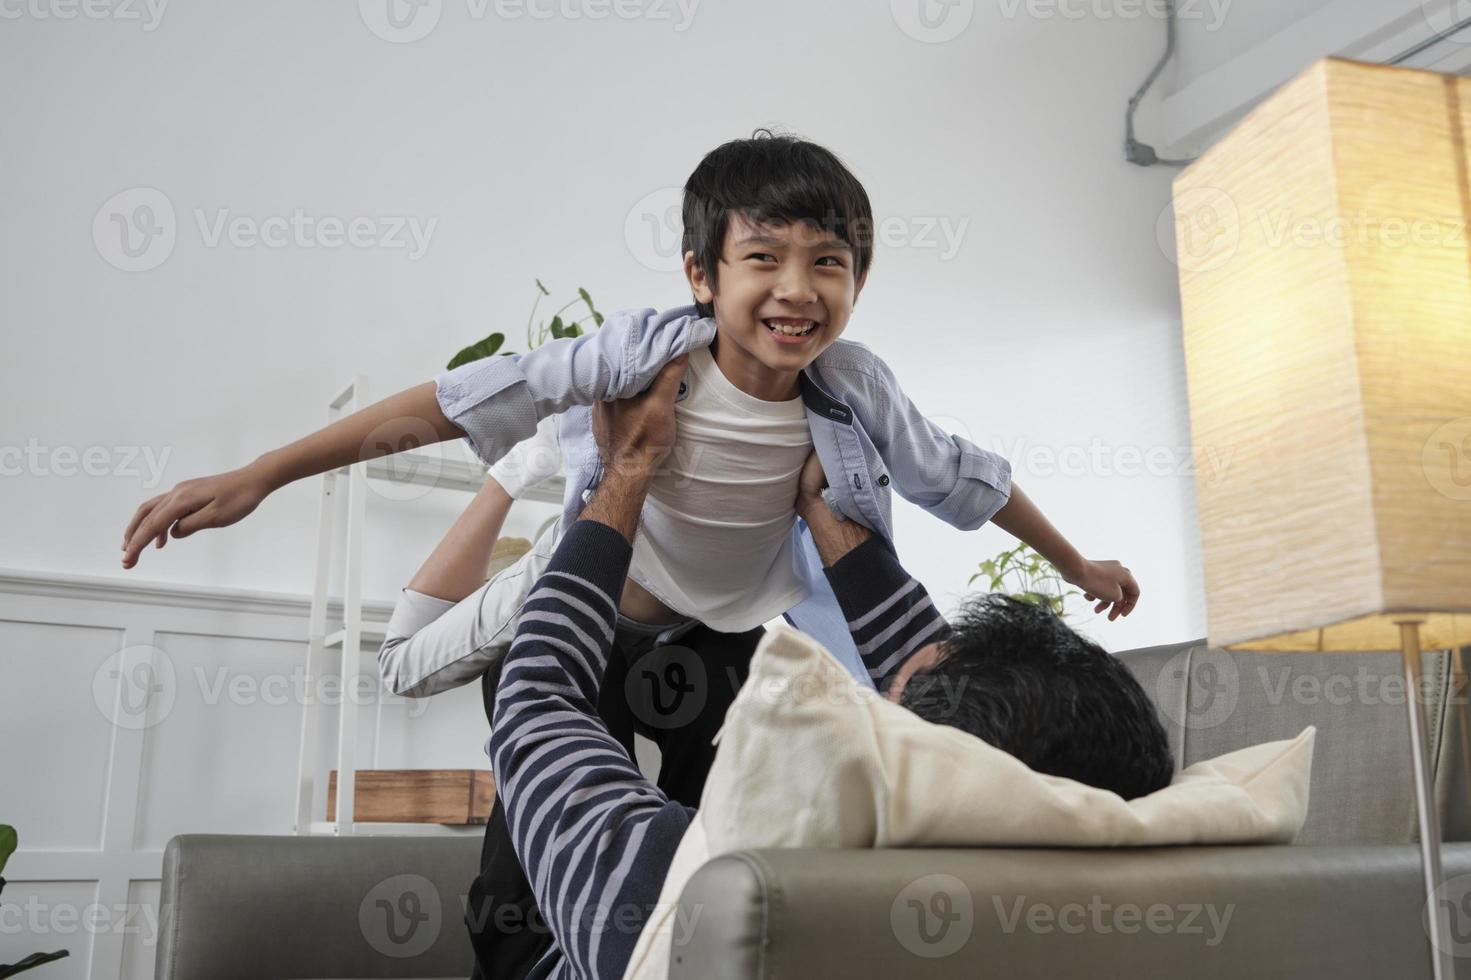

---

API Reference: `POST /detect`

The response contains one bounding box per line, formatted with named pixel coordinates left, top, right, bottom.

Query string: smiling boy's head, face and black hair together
left=683, top=129, right=874, bottom=382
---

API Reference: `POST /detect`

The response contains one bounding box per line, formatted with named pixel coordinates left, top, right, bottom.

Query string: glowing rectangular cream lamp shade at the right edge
left=1174, top=57, right=1471, bottom=652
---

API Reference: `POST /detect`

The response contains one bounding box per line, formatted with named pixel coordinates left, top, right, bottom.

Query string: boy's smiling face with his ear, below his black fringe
left=684, top=212, right=863, bottom=402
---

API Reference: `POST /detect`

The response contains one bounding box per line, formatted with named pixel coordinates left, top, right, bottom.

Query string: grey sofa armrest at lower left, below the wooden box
left=154, top=834, right=481, bottom=980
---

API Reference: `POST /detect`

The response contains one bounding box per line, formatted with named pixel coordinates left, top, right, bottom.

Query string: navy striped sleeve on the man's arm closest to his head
left=824, top=534, right=949, bottom=690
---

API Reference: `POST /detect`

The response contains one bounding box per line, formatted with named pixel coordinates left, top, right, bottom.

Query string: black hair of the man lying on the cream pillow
left=899, top=593, right=1174, bottom=799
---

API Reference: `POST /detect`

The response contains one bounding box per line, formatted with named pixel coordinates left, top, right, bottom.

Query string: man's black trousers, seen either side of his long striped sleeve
left=465, top=624, right=765, bottom=980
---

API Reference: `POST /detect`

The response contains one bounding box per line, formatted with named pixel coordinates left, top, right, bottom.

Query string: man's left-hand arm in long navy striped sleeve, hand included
left=488, top=362, right=693, bottom=980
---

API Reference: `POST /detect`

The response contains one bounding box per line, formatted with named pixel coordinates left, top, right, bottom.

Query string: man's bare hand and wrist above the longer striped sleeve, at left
left=583, top=356, right=688, bottom=544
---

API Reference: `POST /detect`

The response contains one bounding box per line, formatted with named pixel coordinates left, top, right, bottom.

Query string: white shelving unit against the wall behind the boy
left=293, top=377, right=563, bottom=836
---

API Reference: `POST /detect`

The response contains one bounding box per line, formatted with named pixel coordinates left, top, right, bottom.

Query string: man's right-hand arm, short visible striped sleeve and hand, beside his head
left=796, top=453, right=949, bottom=692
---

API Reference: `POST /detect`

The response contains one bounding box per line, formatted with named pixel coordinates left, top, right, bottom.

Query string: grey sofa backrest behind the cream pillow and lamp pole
left=1119, top=640, right=1471, bottom=845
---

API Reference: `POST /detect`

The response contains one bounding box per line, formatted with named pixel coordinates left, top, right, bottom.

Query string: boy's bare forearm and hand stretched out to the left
left=122, top=381, right=465, bottom=568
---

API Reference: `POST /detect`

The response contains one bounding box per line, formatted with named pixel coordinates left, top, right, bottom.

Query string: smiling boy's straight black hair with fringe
left=680, top=129, right=874, bottom=316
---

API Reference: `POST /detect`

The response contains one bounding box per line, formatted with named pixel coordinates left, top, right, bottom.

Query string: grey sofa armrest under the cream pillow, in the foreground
left=669, top=845, right=1471, bottom=980
